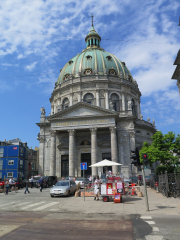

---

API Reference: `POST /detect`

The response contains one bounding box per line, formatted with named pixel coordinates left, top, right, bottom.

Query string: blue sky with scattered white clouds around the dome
left=0, top=0, right=180, bottom=148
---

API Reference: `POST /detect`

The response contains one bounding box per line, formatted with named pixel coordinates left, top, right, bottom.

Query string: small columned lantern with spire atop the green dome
left=85, top=16, right=101, bottom=47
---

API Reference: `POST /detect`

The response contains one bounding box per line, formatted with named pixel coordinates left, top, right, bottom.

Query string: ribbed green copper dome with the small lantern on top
left=57, top=26, right=132, bottom=84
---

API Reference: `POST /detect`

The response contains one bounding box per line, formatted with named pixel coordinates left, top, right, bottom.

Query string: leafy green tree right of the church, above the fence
left=140, top=131, right=180, bottom=172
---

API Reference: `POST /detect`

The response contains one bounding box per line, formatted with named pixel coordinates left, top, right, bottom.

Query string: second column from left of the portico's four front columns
left=68, top=129, right=75, bottom=177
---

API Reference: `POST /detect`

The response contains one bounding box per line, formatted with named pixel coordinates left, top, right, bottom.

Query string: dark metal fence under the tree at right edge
left=150, top=173, right=180, bottom=197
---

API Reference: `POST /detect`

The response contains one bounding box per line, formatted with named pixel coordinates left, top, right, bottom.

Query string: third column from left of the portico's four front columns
left=90, top=128, right=97, bottom=176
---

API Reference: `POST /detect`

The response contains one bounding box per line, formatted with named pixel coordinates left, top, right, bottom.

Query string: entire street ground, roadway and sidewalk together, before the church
left=0, top=188, right=180, bottom=240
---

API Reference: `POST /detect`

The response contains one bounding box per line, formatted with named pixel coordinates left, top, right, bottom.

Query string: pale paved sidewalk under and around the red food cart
left=56, top=186, right=180, bottom=216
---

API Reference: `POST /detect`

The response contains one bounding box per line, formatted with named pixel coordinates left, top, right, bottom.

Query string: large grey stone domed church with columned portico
left=37, top=25, right=156, bottom=178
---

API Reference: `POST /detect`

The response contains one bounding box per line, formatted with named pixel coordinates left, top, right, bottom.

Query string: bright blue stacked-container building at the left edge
left=0, top=138, right=28, bottom=179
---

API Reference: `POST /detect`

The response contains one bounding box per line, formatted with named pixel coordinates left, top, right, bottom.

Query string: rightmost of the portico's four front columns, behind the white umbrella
left=109, top=127, right=118, bottom=174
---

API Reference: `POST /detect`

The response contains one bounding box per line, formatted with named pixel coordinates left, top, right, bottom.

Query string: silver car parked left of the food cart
left=50, top=180, right=77, bottom=197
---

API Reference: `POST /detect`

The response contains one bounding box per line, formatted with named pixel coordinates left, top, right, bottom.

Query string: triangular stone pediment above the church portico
left=48, top=102, right=117, bottom=121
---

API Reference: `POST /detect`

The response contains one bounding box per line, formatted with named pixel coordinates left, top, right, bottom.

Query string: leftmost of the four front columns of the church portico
left=50, top=131, right=56, bottom=176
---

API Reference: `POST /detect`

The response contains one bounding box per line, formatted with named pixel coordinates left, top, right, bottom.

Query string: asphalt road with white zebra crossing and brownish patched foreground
left=0, top=189, right=180, bottom=240
